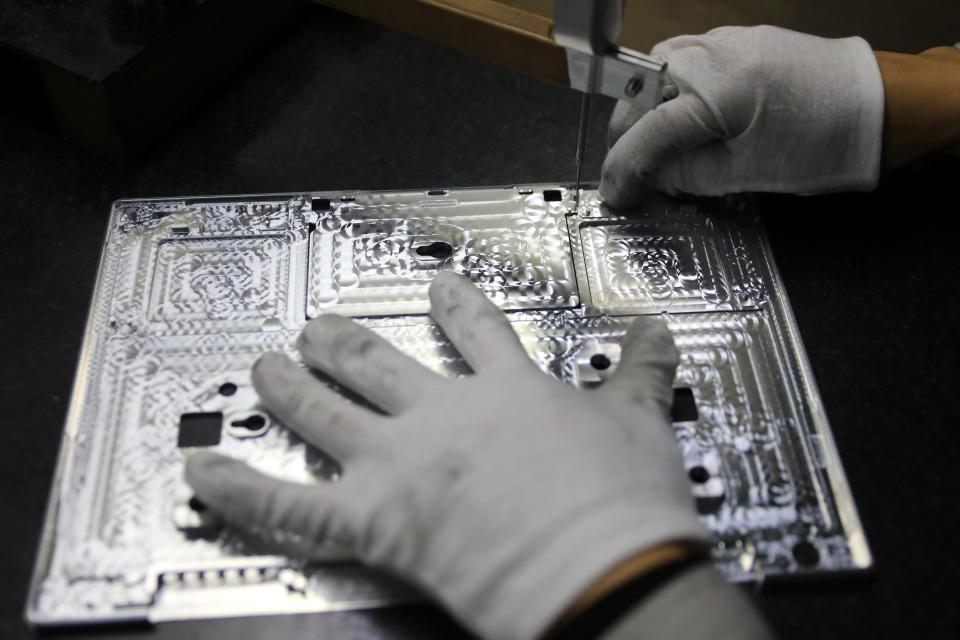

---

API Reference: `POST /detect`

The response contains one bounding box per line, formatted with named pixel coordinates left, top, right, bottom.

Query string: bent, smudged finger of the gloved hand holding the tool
left=600, top=95, right=720, bottom=207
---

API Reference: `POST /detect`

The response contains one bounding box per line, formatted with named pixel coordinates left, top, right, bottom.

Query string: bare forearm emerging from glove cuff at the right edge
left=876, top=47, right=960, bottom=169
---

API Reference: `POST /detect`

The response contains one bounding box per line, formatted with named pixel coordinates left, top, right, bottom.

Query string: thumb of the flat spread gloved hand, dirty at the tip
left=598, top=318, right=679, bottom=416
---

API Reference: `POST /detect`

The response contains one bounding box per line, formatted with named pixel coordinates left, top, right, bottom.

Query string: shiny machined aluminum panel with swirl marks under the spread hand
left=27, top=185, right=872, bottom=625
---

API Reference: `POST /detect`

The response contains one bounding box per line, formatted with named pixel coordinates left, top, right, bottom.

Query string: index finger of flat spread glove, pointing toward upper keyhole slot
left=430, top=271, right=533, bottom=372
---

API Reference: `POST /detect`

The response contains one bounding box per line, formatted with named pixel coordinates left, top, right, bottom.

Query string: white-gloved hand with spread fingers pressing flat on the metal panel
left=187, top=273, right=707, bottom=638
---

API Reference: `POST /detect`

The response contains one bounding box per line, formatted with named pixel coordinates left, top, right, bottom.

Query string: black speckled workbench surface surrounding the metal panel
left=0, top=9, right=960, bottom=639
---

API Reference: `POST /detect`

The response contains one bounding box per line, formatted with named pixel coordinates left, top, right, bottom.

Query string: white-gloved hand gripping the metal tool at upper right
left=600, top=26, right=884, bottom=207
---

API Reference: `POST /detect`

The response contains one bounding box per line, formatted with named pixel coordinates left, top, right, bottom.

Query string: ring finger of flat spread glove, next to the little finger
left=252, top=353, right=383, bottom=462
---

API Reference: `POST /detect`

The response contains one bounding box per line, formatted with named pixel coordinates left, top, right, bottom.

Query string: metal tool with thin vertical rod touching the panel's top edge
left=553, top=0, right=667, bottom=208
